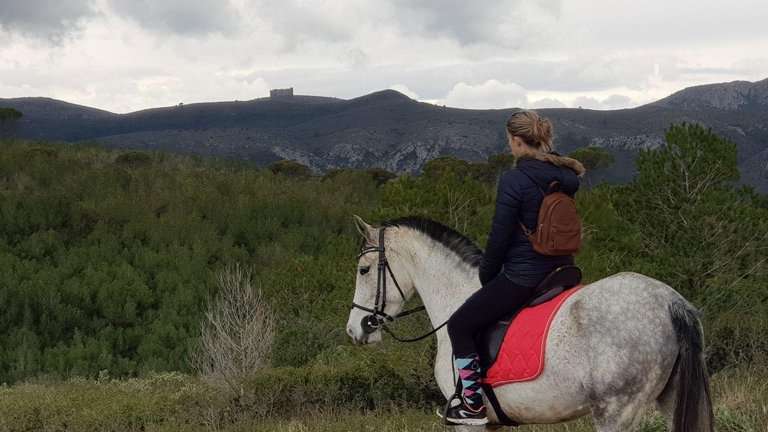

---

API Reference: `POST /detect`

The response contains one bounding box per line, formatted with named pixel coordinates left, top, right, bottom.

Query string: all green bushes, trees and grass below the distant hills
left=0, top=124, right=768, bottom=431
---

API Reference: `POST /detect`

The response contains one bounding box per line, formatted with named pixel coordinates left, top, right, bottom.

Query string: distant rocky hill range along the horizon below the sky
left=0, top=79, right=768, bottom=192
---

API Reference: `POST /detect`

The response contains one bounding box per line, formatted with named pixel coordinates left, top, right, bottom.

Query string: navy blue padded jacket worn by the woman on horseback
left=480, top=158, right=579, bottom=287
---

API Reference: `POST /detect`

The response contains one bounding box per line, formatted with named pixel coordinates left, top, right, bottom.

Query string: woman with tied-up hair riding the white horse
left=446, top=110, right=585, bottom=425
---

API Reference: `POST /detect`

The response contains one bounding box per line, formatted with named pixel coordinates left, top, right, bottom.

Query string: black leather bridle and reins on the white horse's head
left=352, top=227, right=447, bottom=342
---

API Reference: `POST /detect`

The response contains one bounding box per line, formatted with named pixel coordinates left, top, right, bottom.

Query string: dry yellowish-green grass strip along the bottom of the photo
left=0, top=366, right=768, bottom=432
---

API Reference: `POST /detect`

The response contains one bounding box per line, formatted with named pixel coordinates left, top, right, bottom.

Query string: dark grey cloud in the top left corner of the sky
left=0, top=0, right=95, bottom=44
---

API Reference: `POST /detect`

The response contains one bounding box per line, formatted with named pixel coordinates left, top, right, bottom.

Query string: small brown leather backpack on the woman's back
left=520, top=171, right=581, bottom=256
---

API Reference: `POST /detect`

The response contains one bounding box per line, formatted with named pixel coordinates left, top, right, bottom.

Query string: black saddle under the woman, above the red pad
left=477, top=265, right=581, bottom=377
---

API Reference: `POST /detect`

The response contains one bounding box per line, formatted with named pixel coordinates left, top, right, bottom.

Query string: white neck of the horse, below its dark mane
left=392, top=230, right=480, bottom=326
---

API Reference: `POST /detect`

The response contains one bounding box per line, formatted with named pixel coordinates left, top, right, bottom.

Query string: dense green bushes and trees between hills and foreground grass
left=0, top=125, right=768, bottom=388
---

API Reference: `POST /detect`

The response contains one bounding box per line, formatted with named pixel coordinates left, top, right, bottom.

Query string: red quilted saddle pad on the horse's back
left=483, top=285, right=582, bottom=387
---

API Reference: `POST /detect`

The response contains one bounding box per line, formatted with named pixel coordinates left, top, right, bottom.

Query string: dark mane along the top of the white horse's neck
left=381, top=216, right=483, bottom=267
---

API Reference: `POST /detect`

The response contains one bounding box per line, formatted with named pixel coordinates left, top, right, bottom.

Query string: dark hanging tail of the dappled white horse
left=669, top=298, right=715, bottom=432
